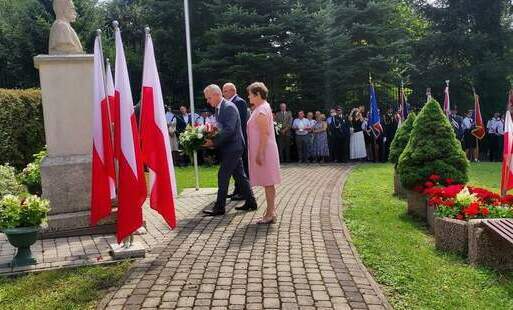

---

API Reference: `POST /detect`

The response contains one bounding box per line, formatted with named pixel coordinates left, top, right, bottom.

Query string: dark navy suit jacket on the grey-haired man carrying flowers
left=214, top=99, right=246, bottom=154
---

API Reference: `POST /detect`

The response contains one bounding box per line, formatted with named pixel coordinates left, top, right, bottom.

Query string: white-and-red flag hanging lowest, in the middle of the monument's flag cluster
left=114, top=27, right=146, bottom=243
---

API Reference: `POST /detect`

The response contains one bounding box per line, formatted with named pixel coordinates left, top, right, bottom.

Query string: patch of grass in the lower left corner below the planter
left=0, top=262, right=131, bottom=310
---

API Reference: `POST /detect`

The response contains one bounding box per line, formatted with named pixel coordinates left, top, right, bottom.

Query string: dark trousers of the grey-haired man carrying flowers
left=214, top=151, right=255, bottom=210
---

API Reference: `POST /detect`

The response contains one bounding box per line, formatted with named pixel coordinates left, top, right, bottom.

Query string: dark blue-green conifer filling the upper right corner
left=412, top=0, right=512, bottom=115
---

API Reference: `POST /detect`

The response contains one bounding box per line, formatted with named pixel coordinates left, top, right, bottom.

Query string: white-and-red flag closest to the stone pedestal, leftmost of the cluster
left=90, top=35, right=116, bottom=226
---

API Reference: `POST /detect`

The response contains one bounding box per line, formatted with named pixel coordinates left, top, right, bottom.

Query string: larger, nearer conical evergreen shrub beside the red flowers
left=397, top=99, right=469, bottom=189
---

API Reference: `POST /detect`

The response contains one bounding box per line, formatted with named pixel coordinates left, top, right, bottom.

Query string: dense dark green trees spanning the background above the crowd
left=0, top=0, right=513, bottom=118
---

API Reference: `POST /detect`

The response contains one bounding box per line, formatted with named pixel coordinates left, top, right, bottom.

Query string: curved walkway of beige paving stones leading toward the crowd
left=99, top=165, right=390, bottom=309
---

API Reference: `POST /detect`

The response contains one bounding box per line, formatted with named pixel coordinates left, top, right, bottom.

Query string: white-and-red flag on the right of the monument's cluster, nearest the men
left=141, top=29, right=176, bottom=228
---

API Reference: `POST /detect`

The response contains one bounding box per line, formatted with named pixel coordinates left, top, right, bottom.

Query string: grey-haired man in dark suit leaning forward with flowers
left=203, top=84, right=257, bottom=216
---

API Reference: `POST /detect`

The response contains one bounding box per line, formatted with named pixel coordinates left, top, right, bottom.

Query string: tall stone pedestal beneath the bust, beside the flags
left=34, top=54, right=117, bottom=238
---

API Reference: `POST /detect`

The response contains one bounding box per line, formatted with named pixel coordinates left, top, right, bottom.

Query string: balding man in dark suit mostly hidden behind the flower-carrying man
left=223, top=83, right=249, bottom=200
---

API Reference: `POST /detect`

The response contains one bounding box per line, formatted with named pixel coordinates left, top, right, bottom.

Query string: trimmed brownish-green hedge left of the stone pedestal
left=0, top=89, right=45, bottom=169
